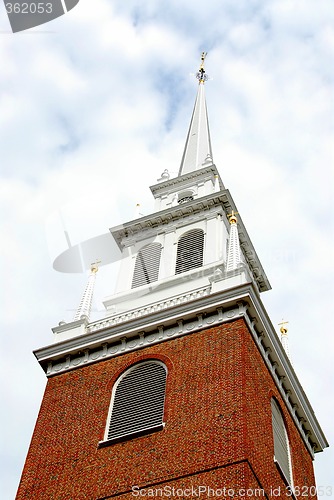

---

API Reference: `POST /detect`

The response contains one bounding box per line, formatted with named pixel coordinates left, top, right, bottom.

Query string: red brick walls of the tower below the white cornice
left=17, top=319, right=314, bottom=500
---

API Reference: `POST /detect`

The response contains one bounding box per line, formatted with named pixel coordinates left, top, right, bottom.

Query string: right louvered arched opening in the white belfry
left=175, top=229, right=204, bottom=274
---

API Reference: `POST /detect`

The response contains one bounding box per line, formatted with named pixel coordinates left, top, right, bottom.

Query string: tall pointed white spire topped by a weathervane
left=179, top=52, right=213, bottom=176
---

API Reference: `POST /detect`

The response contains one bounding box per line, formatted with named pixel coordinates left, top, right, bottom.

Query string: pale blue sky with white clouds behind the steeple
left=0, top=0, right=334, bottom=500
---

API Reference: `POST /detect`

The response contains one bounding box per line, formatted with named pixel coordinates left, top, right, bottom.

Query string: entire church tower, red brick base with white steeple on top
left=17, top=54, right=328, bottom=500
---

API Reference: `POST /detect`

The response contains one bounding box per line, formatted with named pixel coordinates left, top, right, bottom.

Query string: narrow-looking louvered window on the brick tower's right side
left=271, top=398, right=292, bottom=485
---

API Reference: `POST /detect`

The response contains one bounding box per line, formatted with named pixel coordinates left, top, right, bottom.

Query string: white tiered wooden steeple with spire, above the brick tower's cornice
left=104, top=53, right=270, bottom=315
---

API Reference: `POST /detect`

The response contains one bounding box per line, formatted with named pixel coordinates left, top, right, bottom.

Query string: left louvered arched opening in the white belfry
left=132, top=243, right=161, bottom=288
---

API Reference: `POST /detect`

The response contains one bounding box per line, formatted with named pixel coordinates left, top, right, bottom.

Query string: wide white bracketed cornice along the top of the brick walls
left=34, top=277, right=328, bottom=456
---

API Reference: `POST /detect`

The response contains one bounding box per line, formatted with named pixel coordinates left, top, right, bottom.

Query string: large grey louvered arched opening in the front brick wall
left=108, top=361, right=167, bottom=440
